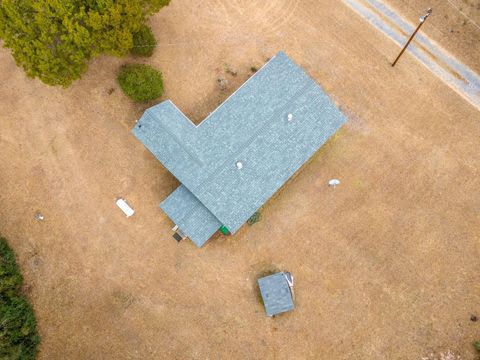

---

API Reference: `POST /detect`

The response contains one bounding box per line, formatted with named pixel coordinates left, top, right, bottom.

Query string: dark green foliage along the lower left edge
left=0, top=238, right=40, bottom=360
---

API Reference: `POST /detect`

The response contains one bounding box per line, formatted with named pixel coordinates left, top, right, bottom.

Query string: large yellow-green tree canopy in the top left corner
left=0, top=0, right=170, bottom=86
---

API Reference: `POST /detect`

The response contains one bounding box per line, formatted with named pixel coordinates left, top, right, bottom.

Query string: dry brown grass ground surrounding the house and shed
left=0, top=0, right=480, bottom=360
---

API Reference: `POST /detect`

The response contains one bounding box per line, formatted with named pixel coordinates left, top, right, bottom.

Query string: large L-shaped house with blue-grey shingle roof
left=132, top=52, right=346, bottom=247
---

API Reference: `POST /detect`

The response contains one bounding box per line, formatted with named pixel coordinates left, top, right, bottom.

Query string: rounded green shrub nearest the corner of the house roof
left=117, top=64, right=163, bottom=102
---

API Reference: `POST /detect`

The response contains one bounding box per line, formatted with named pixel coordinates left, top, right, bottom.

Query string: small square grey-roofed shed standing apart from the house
left=258, top=272, right=294, bottom=316
